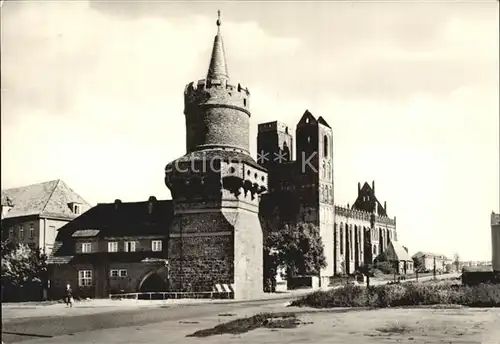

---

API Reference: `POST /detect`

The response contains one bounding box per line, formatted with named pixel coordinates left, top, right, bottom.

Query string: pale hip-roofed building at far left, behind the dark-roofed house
left=2, top=179, right=91, bottom=254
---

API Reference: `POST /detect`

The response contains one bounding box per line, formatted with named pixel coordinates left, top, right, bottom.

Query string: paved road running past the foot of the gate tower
left=2, top=274, right=460, bottom=344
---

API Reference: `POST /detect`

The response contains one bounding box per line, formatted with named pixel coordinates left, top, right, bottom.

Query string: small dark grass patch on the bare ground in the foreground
left=187, top=313, right=301, bottom=337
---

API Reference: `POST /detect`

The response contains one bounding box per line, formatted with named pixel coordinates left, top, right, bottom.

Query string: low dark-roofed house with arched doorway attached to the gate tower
left=49, top=197, right=173, bottom=298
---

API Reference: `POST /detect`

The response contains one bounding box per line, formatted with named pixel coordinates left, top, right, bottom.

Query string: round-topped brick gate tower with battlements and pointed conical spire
left=165, top=12, right=267, bottom=299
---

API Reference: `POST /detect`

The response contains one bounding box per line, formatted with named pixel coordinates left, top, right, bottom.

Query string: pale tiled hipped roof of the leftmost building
left=2, top=179, right=91, bottom=219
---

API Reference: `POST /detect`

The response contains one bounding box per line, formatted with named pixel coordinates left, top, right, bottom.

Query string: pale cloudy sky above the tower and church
left=1, top=0, right=500, bottom=260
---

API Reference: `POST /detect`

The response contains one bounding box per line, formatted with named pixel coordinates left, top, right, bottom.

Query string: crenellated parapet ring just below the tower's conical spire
left=184, top=79, right=250, bottom=115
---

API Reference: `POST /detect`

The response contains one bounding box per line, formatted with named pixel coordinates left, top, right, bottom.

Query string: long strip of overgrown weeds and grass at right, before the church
left=291, top=280, right=500, bottom=308
